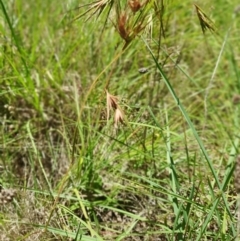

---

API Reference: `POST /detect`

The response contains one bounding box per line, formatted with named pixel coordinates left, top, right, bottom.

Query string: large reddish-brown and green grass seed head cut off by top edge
left=74, top=0, right=153, bottom=49
